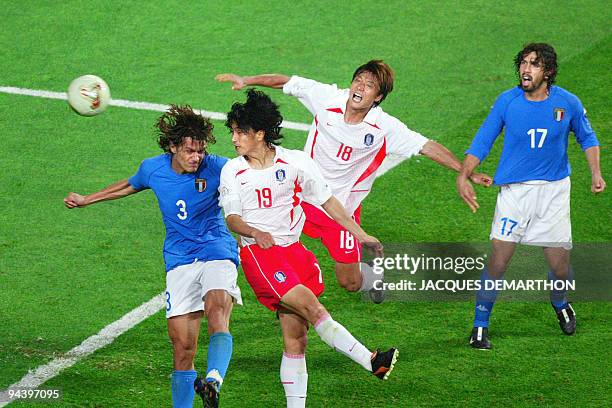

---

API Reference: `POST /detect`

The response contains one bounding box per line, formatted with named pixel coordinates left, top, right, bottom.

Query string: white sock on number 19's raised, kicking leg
left=315, top=314, right=372, bottom=372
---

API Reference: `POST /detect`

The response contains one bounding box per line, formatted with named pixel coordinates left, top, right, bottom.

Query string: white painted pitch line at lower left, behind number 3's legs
left=0, top=293, right=165, bottom=407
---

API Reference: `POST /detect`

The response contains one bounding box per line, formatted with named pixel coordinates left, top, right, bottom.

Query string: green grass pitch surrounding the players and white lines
left=0, top=0, right=612, bottom=407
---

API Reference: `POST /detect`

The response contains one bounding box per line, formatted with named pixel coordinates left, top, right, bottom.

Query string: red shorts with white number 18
left=301, top=202, right=361, bottom=263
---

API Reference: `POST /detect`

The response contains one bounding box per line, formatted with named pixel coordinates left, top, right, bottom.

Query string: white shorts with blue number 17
left=489, top=177, right=572, bottom=250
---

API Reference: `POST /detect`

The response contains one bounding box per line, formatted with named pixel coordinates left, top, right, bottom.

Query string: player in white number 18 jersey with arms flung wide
left=216, top=60, right=491, bottom=303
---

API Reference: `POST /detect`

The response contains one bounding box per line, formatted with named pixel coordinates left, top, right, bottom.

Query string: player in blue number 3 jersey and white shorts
left=64, top=105, right=242, bottom=408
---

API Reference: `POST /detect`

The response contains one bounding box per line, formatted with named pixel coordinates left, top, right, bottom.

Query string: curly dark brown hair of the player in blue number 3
left=155, top=105, right=216, bottom=153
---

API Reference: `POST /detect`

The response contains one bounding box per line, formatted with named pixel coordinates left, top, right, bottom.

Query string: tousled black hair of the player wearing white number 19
left=225, top=88, right=283, bottom=147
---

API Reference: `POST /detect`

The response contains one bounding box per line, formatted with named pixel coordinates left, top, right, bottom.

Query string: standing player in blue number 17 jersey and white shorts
left=457, top=43, right=606, bottom=349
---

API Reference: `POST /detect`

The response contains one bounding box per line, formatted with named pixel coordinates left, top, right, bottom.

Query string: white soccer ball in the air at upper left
left=68, top=75, right=111, bottom=116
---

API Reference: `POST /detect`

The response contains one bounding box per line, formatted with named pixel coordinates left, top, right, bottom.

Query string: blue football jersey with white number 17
left=466, top=86, right=599, bottom=185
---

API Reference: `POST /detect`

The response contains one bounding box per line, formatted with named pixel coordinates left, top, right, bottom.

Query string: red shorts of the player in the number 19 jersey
left=240, top=242, right=325, bottom=310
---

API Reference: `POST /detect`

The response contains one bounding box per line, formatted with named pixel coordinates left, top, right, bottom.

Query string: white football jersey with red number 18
left=283, top=76, right=428, bottom=214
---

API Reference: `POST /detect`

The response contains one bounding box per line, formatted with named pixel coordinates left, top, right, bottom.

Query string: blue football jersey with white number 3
left=128, top=153, right=238, bottom=271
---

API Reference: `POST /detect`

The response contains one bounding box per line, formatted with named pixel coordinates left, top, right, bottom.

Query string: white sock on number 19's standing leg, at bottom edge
left=281, top=353, right=308, bottom=408
